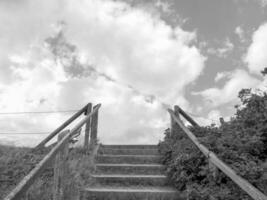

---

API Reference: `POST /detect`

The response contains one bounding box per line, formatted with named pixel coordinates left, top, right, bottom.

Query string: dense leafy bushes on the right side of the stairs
left=160, top=89, right=267, bottom=200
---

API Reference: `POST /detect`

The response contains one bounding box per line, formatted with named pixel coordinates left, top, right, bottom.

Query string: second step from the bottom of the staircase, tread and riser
left=92, top=174, right=168, bottom=186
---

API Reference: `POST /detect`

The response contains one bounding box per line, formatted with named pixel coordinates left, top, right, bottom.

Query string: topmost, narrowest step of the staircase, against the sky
left=99, top=147, right=159, bottom=155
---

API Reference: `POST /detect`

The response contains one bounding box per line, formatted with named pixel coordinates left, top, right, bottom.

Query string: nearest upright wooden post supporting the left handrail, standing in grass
left=53, top=130, right=69, bottom=200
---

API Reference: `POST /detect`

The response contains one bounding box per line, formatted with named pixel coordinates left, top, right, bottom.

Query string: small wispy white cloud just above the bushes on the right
left=193, top=69, right=260, bottom=107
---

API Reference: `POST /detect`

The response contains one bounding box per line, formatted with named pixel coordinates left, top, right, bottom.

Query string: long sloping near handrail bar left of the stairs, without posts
left=4, top=104, right=101, bottom=200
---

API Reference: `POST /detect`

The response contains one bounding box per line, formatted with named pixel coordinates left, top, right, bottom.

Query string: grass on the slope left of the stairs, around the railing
left=0, top=145, right=94, bottom=200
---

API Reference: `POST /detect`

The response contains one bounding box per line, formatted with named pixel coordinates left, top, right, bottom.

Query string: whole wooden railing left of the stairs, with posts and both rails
left=4, top=103, right=101, bottom=200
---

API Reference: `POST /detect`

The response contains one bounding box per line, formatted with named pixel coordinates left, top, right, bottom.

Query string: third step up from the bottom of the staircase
left=96, top=163, right=164, bottom=175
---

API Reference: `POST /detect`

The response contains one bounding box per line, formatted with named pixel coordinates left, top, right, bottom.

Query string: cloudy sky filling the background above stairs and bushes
left=0, top=0, right=267, bottom=146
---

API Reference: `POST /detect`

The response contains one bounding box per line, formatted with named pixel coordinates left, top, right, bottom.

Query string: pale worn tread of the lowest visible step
left=85, top=186, right=177, bottom=193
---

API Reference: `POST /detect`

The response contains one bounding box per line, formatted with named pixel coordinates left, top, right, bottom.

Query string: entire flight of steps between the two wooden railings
left=81, top=145, right=185, bottom=200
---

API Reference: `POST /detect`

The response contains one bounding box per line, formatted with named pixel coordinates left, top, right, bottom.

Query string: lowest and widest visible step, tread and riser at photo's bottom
left=80, top=186, right=186, bottom=200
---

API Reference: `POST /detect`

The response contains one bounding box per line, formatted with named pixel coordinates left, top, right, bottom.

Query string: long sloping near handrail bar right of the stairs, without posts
left=168, top=109, right=267, bottom=200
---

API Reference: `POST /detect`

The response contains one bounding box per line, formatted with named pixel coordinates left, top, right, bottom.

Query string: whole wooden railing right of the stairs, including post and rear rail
left=168, top=106, right=267, bottom=200
